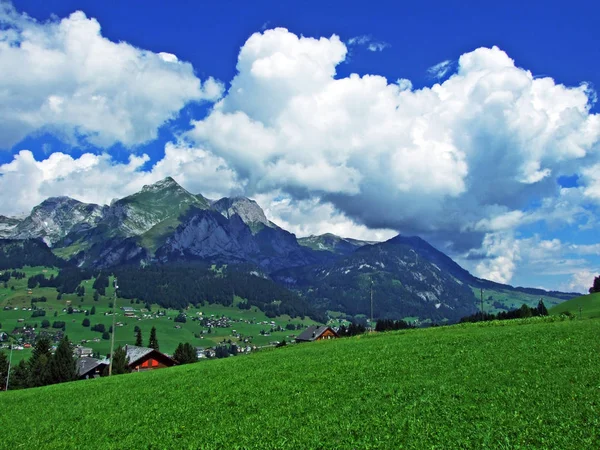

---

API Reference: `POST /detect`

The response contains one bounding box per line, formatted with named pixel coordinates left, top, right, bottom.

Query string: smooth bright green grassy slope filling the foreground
left=0, top=318, right=600, bottom=449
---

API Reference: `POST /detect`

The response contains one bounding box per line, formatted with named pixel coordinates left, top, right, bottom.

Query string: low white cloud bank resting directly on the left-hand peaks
left=0, top=143, right=243, bottom=215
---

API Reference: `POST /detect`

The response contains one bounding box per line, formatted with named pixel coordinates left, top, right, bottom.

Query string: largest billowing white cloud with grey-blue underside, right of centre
left=187, top=28, right=600, bottom=268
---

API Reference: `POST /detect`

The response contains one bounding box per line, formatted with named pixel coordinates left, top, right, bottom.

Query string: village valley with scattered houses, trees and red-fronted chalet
left=0, top=267, right=346, bottom=379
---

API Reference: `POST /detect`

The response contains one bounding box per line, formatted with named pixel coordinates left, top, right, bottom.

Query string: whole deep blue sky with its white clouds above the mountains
left=0, top=0, right=600, bottom=292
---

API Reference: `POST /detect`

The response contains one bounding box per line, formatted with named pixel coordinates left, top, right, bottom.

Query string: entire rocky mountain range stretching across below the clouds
left=0, top=177, right=574, bottom=321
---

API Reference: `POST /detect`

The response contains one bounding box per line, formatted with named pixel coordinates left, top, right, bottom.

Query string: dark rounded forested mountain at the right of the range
left=274, top=238, right=476, bottom=321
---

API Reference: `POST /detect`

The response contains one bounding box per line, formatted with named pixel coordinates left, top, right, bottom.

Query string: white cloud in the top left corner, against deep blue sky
left=0, top=2, right=223, bottom=148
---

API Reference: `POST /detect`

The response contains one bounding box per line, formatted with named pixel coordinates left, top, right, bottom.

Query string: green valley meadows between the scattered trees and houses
left=0, top=267, right=315, bottom=362
